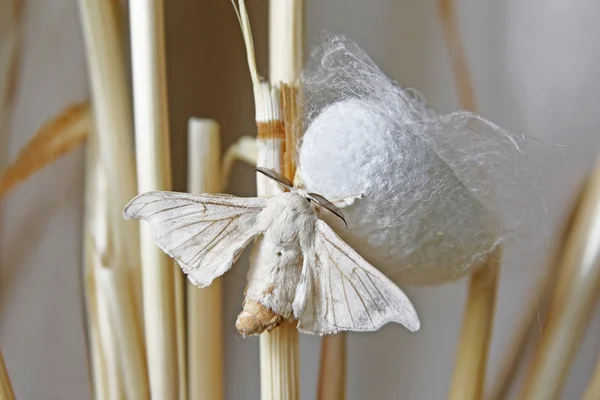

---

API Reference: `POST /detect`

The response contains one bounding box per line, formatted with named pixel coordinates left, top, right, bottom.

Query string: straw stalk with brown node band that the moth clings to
left=234, top=0, right=302, bottom=400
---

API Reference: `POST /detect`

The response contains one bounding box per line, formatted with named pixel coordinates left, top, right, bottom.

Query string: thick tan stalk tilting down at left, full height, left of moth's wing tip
left=79, top=0, right=149, bottom=399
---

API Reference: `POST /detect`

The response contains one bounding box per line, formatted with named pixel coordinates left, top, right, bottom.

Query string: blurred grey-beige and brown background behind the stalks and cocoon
left=0, top=0, right=600, bottom=400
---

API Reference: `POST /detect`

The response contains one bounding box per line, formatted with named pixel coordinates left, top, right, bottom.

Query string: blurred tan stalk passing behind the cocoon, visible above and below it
left=438, top=0, right=502, bottom=400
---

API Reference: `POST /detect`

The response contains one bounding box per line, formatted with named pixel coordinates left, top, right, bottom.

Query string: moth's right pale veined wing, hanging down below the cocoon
left=294, top=220, right=420, bottom=335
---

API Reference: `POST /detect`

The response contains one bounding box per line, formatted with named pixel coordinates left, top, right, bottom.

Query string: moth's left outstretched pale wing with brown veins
left=123, top=191, right=267, bottom=287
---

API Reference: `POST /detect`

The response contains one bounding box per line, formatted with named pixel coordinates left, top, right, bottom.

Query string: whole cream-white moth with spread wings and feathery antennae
left=124, top=168, right=420, bottom=335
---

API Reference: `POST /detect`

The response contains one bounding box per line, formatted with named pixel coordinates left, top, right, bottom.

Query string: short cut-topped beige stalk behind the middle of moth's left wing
left=187, top=118, right=223, bottom=400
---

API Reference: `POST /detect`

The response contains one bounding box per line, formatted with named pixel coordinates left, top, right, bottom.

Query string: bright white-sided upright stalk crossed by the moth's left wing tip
left=129, top=0, right=180, bottom=399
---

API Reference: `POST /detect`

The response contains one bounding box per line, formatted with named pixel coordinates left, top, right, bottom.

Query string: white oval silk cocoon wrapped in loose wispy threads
left=298, top=36, right=542, bottom=284
